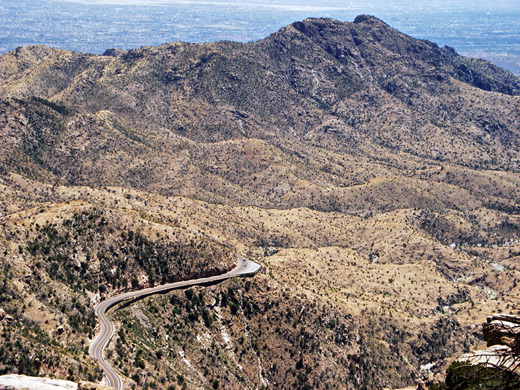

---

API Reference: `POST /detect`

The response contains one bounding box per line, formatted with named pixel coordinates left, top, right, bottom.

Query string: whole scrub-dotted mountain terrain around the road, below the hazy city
left=0, top=15, right=520, bottom=389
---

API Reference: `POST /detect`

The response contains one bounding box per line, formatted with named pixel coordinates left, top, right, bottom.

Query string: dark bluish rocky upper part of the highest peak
left=274, top=15, right=520, bottom=95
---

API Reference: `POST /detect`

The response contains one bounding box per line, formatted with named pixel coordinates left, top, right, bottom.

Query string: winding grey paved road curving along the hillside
left=88, top=255, right=261, bottom=390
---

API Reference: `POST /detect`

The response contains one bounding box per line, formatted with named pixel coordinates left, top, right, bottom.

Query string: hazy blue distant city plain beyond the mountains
left=0, top=0, right=520, bottom=74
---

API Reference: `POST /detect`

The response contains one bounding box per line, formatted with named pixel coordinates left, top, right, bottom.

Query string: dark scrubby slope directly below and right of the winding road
left=103, top=275, right=482, bottom=389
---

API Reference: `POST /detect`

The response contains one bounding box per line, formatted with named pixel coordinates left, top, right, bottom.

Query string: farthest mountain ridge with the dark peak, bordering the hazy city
left=0, top=16, right=520, bottom=169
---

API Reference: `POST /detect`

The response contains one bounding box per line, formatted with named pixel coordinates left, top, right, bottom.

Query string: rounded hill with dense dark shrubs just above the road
left=25, top=207, right=235, bottom=293
